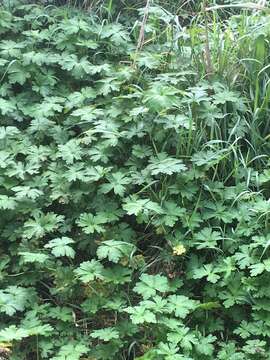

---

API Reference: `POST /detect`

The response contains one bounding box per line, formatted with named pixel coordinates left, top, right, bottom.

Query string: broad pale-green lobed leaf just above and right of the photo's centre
left=147, top=152, right=187, bottom=175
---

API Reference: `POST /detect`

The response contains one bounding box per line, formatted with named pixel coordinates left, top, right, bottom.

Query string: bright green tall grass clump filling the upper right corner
left=187, top=4, right=270, bottom=163
